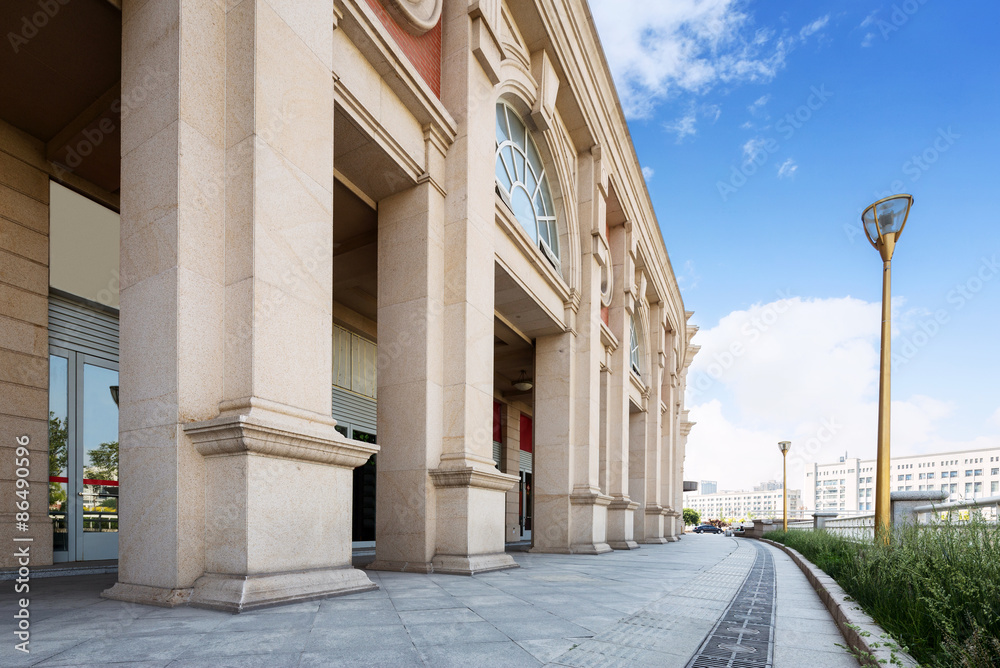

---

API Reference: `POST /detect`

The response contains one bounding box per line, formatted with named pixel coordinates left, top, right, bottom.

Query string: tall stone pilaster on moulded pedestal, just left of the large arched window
left=431, top=0, right=517, bottom=573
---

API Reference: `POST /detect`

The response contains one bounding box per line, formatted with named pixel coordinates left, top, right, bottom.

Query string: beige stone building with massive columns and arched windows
left=0, top=0, right=697, bottom=610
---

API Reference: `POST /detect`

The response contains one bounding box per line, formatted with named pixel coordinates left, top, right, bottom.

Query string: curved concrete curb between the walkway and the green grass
left=758, top=538, right=920, bottom=668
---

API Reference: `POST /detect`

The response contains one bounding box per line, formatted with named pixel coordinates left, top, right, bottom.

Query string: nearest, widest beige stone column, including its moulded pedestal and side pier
left=107, top=0, right=377, bottom=612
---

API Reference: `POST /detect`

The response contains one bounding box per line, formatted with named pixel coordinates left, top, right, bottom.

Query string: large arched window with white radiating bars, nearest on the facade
left=496, top=102, right=559, bottom=269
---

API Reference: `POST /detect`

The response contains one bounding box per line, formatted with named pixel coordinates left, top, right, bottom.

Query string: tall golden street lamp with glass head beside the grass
left=861, top=195, right=913, bottom=541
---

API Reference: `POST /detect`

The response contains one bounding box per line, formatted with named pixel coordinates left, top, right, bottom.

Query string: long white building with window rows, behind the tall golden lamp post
left=803, top=448, right=1000, bottom=513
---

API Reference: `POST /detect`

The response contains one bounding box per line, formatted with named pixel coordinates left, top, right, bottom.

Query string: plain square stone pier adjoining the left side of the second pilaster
left=369, top=182, right=444, bottom=572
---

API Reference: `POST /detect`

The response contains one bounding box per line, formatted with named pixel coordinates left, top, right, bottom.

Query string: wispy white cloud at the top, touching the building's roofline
left=591, top=0, right=789, bottom=118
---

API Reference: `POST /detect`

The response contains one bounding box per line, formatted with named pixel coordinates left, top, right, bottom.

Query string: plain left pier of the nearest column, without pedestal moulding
left=104, top=0, right=226, bottom=605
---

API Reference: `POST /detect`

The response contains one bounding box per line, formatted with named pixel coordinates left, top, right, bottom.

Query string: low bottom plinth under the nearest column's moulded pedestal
left=191, top=568, right=378, bottom=613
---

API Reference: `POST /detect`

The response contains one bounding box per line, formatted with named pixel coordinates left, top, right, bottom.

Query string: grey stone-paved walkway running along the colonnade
left=0, top=535, right=858, bottom=668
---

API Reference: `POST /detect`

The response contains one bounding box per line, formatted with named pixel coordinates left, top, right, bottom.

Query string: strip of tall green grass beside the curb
left=766, top=518, right=1000, bottom=668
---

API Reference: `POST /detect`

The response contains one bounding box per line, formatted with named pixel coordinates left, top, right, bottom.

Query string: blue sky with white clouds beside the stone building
left=591, top=0, right=1000, bottom=489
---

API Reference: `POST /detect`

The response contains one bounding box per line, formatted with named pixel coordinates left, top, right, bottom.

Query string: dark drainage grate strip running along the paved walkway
left=687, top=541, right=775, bottom=668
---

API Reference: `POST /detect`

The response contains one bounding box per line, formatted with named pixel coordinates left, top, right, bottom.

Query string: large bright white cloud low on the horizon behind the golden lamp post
left=684, top=297, right=1000, bottom=496
